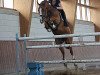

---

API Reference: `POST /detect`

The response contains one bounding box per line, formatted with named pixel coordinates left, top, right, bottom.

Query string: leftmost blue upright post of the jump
left=16, top=34, right=20, bottom=75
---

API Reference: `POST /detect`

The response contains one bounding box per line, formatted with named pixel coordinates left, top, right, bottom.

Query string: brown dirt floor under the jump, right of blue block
left=45, top=69, right=100, bottom=75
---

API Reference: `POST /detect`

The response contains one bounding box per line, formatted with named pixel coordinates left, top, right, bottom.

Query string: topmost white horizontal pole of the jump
left=19, top=32, right=100, bottom=40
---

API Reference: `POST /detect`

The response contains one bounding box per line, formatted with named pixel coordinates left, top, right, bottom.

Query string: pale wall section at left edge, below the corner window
left=0, top=8, right=20, bottom=40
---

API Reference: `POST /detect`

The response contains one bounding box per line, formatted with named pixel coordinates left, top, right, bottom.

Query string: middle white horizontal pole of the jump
left=26, top=42, right=100, bottom=49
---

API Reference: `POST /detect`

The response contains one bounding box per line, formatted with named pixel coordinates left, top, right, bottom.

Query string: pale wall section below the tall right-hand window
left=73, top=20, right=95, bottom=41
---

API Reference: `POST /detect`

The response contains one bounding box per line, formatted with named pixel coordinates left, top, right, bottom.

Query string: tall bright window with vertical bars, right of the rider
left=76, top=0, right=90, bottom=21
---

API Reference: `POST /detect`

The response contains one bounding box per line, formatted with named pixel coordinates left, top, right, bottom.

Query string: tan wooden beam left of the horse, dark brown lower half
left=14, top=0, right=33, bottom=36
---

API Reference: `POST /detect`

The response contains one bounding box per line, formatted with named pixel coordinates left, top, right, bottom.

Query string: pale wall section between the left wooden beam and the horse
left=30, top=13, right=53, bottom=41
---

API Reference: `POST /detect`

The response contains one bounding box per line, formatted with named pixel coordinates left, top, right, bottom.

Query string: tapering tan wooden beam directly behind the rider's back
left=61, top=0, right=77, bottom=33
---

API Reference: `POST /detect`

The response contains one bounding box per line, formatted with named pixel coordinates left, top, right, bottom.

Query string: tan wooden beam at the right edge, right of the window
left=90, top=0, right=100, bottom=41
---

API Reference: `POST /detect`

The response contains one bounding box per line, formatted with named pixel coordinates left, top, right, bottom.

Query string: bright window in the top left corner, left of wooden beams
left=0, top=0, right=13, bottom=8
